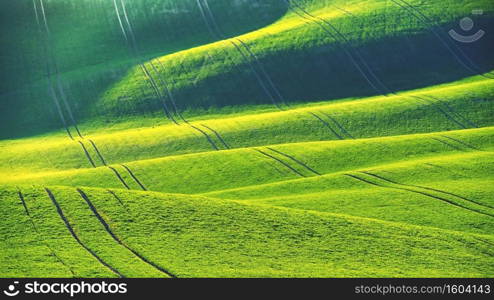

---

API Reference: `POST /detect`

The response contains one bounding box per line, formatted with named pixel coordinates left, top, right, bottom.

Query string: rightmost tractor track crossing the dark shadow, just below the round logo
left=391, top=0, right=494, bottom=79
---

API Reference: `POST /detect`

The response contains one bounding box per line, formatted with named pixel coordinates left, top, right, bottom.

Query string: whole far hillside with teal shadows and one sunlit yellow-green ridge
left=1, top=0, right=494, bottom=137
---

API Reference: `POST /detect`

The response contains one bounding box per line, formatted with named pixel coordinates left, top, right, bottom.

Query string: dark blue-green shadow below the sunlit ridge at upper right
left=163, top=19, right=494, bottom=109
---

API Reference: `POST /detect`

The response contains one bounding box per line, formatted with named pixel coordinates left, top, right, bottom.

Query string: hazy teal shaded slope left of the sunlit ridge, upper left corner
left=0, top=0, right=286, bottom=139
